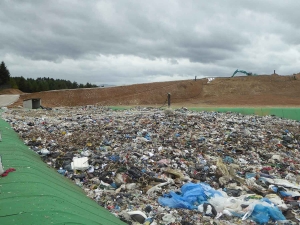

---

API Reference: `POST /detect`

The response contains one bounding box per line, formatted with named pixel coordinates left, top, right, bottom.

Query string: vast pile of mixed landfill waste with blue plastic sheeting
left=2, top=106, right=300, bottom=225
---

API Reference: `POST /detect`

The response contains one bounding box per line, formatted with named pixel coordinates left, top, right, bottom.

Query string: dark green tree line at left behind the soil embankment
left=0, top=62, right=98, bottom=93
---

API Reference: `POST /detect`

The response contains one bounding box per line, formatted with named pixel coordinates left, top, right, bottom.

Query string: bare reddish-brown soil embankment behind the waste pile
left=7, top=74, right=300, bottom=107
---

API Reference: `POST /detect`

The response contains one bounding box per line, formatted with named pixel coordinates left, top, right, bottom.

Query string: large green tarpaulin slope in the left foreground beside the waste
left=0, top=119, right=125, bottom=225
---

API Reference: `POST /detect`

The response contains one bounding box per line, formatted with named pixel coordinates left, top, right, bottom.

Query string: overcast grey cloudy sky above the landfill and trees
left=0, top=0, right=300, bottom=85
